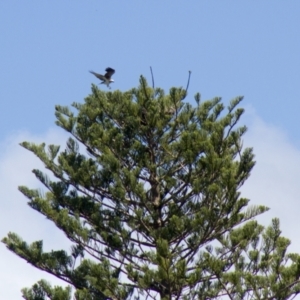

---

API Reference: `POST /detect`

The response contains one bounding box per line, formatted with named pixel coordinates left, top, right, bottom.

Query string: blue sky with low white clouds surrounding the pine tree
left=0, top=0, right=300, bottom=299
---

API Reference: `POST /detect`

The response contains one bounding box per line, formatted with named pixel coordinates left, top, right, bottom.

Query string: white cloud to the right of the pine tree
left=242, top=109, right=300, bottom=253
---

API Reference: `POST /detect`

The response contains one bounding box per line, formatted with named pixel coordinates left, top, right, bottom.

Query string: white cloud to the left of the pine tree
left=0, top=129, right=70, bottom=299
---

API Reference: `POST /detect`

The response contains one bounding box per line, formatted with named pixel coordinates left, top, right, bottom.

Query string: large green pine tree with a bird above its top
left=3, top=77, right=300, bottom=300
